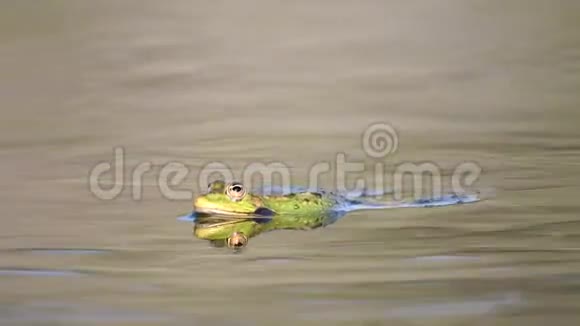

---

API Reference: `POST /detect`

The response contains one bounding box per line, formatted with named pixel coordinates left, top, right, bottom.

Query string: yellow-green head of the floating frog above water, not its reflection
left=193, top=181, right=270, bottom=216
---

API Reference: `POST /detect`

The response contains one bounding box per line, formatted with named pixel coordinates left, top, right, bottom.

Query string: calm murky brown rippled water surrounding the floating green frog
left=0, top=0, right=580, bottom=326
